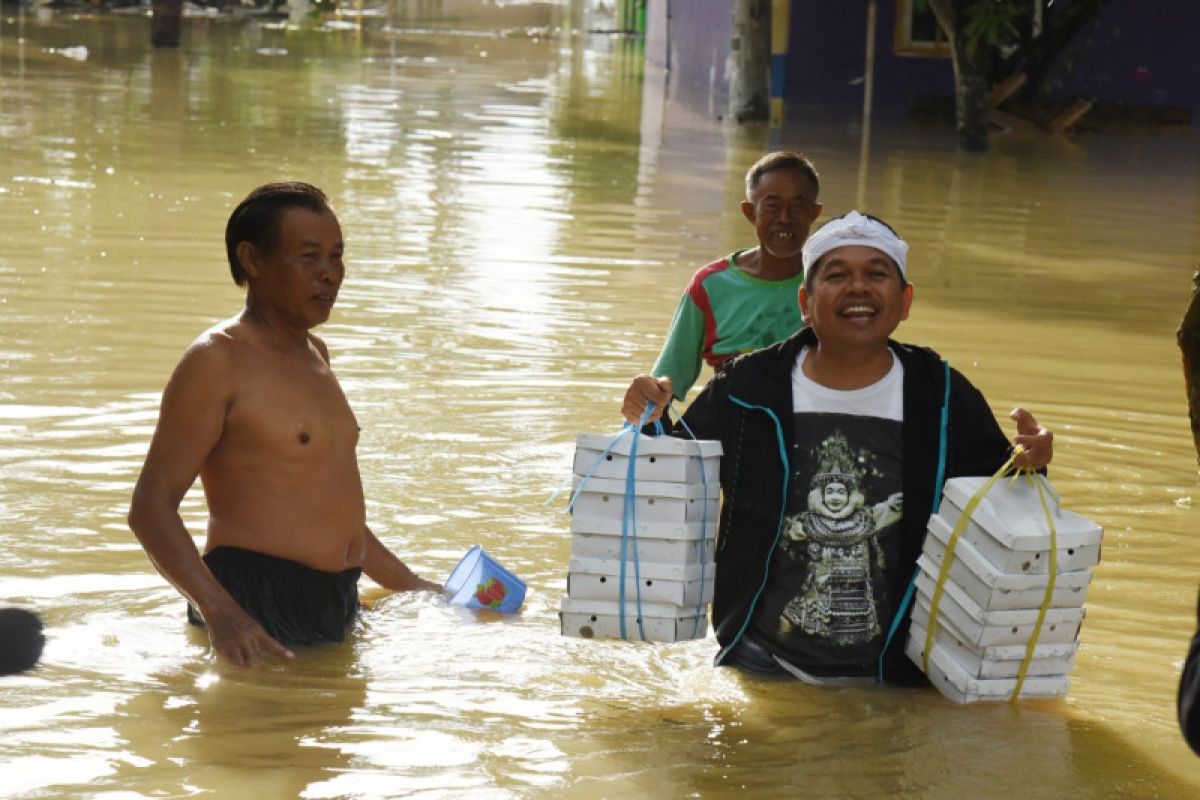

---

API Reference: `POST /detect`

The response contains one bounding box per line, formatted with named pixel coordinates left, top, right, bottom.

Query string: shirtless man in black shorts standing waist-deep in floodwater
left=128, top=184, right=440, bottom=666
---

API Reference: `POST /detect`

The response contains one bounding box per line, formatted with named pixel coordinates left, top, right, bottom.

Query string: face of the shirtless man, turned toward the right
left=238, top=207, right=346, bottom=329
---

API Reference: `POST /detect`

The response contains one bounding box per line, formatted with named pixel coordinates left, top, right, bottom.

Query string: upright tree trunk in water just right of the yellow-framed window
left=929, top=0, right=992, bottom=150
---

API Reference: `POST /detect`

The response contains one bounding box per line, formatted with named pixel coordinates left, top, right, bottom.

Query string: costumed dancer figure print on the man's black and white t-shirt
left=760, top=413, right=902, bottom=670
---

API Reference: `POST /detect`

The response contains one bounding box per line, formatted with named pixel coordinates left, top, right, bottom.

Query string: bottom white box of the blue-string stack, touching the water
left=558, top=597, right=708, bottom=642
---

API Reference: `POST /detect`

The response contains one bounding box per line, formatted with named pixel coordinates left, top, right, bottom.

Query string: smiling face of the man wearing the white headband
left=799, top=245, right=912, bottom=348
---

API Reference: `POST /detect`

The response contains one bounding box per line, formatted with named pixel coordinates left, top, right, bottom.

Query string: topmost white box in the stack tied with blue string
left=574, top=433, right=721, bottom=486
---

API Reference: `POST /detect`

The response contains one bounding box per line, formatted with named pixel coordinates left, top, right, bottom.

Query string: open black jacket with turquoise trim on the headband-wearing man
left=672, top=329, right=1012, bottom=684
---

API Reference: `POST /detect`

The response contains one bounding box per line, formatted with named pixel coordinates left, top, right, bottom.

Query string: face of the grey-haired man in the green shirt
left=742, top=168, right=821, bottom=259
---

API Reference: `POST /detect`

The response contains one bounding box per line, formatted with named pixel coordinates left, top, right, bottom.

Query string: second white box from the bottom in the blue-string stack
left=566, top=557, right=716, bottom=606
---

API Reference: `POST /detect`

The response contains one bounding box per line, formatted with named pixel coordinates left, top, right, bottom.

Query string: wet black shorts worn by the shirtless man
left=187, top=547, right=362, bottom=645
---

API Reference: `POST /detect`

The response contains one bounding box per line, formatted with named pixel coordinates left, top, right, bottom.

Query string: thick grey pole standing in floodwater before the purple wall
left=726, top=0, right=770, bottom=122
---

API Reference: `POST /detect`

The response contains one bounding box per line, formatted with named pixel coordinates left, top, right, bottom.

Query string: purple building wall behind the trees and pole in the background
left=646, top=0, right=1200, bottom=113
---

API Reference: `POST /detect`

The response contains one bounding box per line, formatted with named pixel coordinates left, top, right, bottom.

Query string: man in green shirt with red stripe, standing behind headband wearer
left=622, top=151, right=821, bottom=423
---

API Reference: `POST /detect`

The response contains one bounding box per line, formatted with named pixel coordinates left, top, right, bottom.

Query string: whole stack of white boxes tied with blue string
left=559, top=433, right=721, bottom=642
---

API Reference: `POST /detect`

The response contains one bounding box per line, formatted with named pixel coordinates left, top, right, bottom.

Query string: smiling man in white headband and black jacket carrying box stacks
left=652, top=211, right=1052, bottom=684
